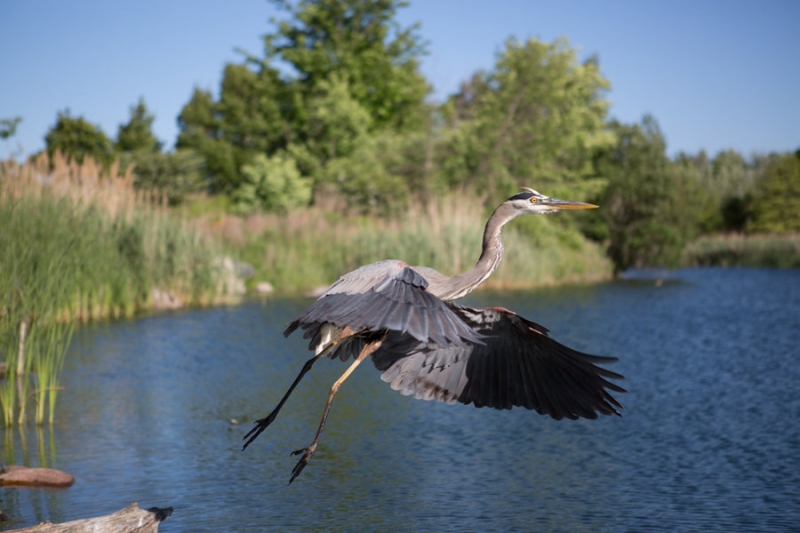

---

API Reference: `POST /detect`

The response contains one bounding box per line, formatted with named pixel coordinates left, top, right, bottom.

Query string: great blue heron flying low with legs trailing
left=242, top=189, right=625, bottom=483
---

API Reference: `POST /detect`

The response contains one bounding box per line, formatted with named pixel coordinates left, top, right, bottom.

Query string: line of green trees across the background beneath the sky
left=0, top=0, right=800, bottom=271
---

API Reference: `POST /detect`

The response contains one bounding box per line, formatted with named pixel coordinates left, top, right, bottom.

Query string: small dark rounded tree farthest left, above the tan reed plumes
left=45, top=109, right=114, bottom=167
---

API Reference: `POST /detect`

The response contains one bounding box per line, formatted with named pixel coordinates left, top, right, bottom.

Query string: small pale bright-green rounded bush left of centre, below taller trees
left=231, top=154, right=311, bottom=214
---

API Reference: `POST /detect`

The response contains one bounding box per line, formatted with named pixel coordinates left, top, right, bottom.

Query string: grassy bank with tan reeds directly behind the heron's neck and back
left=195, top=195, right=612, bottom=293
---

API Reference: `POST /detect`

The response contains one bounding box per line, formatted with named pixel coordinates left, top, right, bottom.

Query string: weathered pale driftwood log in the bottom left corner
left=8, top=502, right=172, bottom=533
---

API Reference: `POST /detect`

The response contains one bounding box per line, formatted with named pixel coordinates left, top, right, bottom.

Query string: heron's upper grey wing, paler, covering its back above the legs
left=284, top=260, right=481, bottom=358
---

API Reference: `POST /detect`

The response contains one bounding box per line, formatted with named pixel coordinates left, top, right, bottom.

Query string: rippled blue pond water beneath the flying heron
left=0, top=269, right=800, bottom=532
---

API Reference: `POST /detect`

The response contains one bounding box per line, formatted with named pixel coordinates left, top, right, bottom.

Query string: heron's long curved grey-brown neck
left=440, top=204, right=517, bottom=300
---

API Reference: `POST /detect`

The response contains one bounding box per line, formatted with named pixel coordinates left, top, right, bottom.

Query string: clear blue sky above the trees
left=0, top=0, right=800, bottom=157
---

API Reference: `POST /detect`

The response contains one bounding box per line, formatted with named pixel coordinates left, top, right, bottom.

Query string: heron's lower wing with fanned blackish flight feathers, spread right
left=372, top=304, right=625, bottom=420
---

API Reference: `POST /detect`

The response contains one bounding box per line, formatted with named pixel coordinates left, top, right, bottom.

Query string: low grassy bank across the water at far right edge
left=683, top=233, right=800, bottom=268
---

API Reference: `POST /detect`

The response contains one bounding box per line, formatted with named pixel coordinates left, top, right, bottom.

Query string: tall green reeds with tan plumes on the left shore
left=0, top=154, right=232, bottom=425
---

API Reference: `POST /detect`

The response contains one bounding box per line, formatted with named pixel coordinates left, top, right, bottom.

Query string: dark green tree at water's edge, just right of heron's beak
left=589, top=116, right=706, bottom=272
